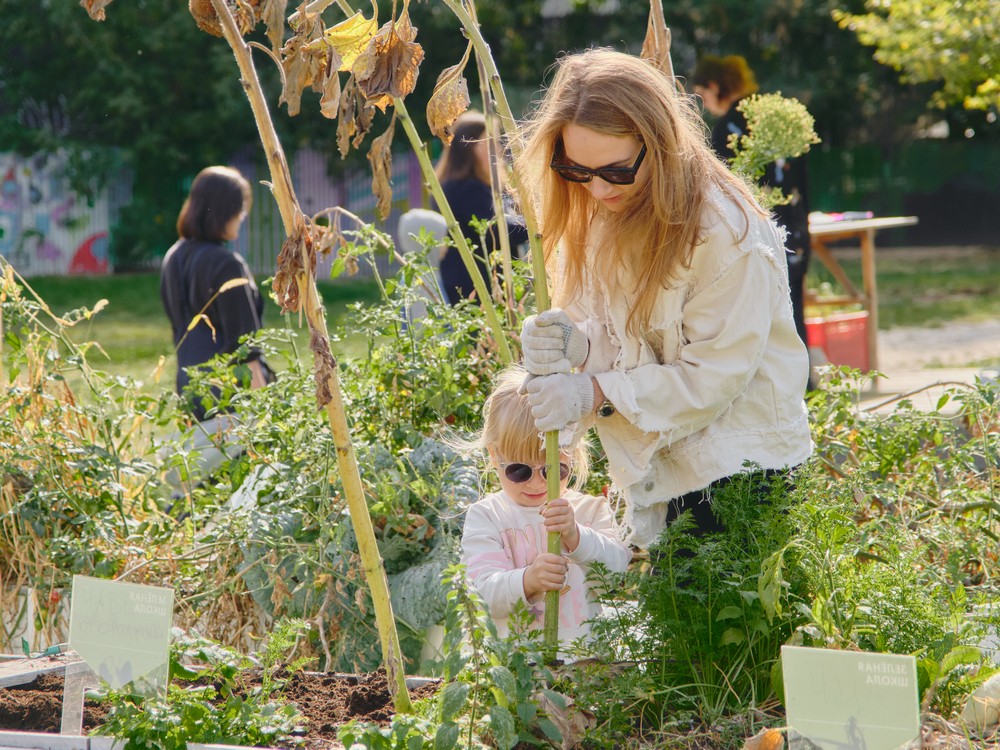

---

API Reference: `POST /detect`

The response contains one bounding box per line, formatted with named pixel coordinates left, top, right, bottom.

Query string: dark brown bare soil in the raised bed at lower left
left=0, top=672, right=437, bottom=750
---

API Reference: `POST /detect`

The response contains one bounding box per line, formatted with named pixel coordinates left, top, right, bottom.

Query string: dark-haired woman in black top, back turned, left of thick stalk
left=160, top=166, right=272, bottom=421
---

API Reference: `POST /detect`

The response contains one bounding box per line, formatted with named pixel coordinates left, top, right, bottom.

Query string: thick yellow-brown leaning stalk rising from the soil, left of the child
left=212, top=0, right=413, bottom=713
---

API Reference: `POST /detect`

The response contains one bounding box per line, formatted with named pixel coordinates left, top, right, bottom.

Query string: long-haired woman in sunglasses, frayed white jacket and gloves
left=517, top=49, right=812, bottom=547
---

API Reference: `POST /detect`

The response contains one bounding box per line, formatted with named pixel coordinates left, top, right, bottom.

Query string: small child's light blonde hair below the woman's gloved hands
left=467, top=365, right=590, bottom=487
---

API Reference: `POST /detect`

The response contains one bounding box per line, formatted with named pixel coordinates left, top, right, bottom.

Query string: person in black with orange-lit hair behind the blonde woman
left=691, top=55, right=810, bottom=368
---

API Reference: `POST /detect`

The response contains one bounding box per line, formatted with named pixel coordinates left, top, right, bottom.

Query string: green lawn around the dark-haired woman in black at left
left=28, top=273, right=379, bottom=388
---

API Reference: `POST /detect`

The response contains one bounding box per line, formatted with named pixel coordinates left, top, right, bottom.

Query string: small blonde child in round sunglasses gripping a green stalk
left=462, top=367, right=632, bottom=643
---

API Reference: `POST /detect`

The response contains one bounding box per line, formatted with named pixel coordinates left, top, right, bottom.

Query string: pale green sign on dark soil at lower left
left=69, top=576, right=174, bottom=690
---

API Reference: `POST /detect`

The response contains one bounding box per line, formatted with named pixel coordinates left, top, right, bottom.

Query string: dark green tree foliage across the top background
left=0, top=0, right=1000, bottom=268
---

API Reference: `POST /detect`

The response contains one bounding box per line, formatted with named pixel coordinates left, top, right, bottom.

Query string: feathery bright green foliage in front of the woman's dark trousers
left=592, top=475, right=794, bottom=726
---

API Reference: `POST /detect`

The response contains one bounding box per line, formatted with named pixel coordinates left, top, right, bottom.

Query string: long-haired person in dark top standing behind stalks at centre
left=436, top=111, right=528, bottom=305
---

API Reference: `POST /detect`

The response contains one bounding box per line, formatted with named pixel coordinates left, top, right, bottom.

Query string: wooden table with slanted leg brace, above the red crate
left=809, top=216, right=917, bottom=370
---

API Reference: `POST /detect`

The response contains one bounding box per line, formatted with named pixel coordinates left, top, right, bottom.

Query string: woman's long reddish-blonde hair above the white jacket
left=515, top=49, right=766, bottom=335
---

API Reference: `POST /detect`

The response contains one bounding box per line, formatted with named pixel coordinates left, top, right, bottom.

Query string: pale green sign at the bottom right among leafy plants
left=781, top=646, right=920, bottom=750
